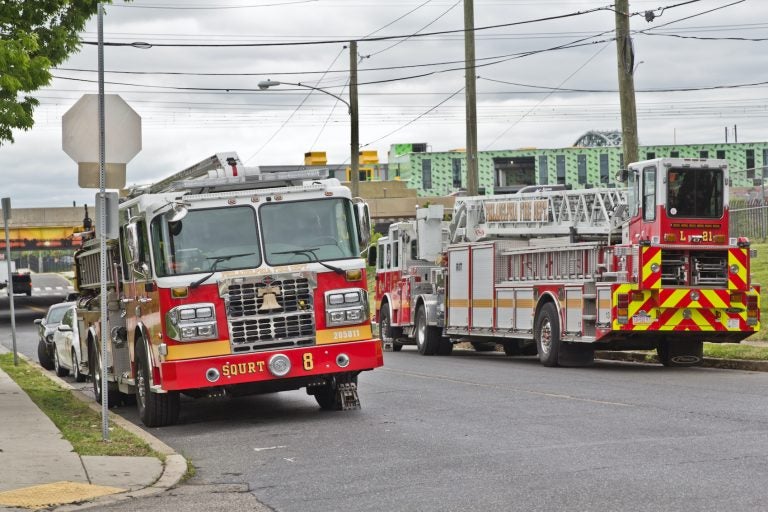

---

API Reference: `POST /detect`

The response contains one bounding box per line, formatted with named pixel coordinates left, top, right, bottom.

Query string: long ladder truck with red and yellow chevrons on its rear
left=369, top=158, right=760, bottom=366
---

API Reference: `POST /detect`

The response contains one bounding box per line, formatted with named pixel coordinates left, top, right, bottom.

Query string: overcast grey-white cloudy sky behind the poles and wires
left=0, top=0, right=768, bottom=208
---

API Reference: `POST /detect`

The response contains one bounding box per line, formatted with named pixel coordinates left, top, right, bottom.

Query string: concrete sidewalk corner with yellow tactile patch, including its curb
left=0, top=346, right=187, bottom=511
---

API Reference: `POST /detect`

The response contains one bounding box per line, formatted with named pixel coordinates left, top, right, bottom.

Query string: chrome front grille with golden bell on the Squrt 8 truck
left=228, top=279, right=315, bottom=353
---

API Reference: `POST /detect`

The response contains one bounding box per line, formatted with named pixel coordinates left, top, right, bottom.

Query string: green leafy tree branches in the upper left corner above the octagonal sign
left=0, top=0, right=111, bottom=146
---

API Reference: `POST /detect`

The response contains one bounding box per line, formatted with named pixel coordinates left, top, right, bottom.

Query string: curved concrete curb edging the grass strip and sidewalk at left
left=3, top=351, right=187, bottom=512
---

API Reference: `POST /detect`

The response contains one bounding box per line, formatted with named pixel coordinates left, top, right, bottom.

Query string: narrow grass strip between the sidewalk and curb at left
left=0, top=354, right=161, bottom=458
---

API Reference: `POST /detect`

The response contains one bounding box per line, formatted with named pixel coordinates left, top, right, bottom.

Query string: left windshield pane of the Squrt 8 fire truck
left=152, top=206, right=261, bottom=277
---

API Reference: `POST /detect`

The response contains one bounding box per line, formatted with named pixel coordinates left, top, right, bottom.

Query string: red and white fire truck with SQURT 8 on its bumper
left=75, top=153, right=383, bottom=426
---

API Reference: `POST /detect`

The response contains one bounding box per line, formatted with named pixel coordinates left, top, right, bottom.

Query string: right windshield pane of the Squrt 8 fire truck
left=259, top=198, right=360, bottom=265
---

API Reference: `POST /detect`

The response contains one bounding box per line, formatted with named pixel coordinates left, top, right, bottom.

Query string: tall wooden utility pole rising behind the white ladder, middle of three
left=464, top=0, right=479, bottom=196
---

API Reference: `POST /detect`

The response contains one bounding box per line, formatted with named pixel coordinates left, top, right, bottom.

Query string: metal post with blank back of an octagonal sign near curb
left=61, top=2, right=141, bottom=441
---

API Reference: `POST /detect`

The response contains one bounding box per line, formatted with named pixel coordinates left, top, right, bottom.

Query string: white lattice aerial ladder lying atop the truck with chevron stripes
left=450, top=188, right=627, bottom=243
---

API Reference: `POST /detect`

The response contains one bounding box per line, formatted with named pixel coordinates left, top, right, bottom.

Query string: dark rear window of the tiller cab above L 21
left=667, top=168, right=723, bottom=219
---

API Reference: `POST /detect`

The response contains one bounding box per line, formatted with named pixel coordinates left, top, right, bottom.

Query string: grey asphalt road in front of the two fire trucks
left=0, top=305, right=768, bottom=512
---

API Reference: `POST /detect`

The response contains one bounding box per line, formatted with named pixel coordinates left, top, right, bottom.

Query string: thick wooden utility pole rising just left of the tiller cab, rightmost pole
left=615, top=0, right=638, bottom=167
